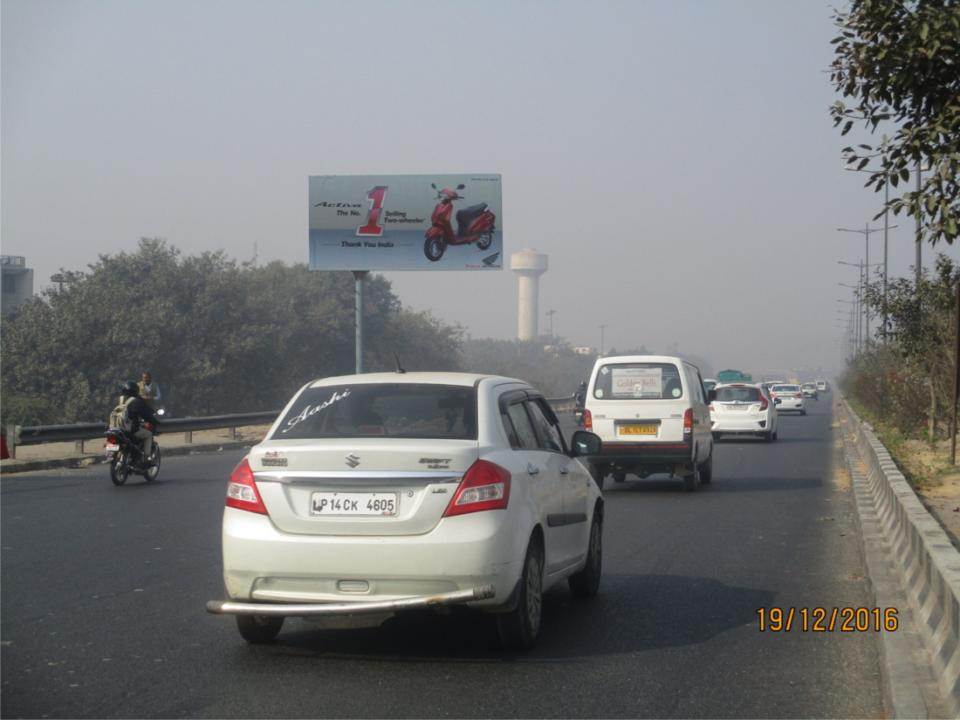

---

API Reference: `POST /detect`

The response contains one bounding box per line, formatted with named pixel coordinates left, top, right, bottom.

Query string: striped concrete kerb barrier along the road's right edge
left=837, top=399, right=960, bottom=717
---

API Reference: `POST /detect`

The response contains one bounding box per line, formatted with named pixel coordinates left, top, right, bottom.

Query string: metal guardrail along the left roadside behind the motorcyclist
left=6, top=395, right=576, bottom=457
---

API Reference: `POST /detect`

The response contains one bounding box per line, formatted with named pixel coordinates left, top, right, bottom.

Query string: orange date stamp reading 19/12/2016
left=756, top=607, right=900, bottom=633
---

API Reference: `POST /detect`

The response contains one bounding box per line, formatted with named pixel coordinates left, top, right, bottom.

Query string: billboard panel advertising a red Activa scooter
left=308, top=174, right=503, bottom=270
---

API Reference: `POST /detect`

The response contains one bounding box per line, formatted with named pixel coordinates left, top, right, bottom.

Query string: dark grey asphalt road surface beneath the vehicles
left=0, top=399, right=883, bottom=717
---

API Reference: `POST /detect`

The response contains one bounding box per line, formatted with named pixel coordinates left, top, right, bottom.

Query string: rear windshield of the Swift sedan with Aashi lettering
left=272, top=383, right=477, bottom=440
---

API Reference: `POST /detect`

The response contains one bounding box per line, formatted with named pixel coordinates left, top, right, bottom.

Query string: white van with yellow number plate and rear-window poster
left=583, top=355, right=713, bottom=491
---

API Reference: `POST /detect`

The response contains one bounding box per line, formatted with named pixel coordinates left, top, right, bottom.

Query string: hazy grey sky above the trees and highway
left=0, top=0, right=957, bottom=376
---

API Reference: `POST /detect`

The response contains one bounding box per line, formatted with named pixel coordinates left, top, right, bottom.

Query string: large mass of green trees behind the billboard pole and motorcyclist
left=0, top=239, right=461, bottom=424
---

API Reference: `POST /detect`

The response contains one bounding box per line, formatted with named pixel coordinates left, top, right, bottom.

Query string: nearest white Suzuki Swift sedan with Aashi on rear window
left=207, top=373, right=603, bottom=648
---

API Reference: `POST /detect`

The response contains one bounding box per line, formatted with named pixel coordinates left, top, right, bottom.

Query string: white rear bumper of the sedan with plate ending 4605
left=223, top=507, right=522, bottom=614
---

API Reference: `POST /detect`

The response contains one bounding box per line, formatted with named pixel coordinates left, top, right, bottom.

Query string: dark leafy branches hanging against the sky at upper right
left=830, top=0, right=960, bottom=244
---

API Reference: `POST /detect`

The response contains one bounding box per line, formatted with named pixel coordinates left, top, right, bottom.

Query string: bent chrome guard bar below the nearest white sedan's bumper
left=207, top=585, right=496, bottom=617
